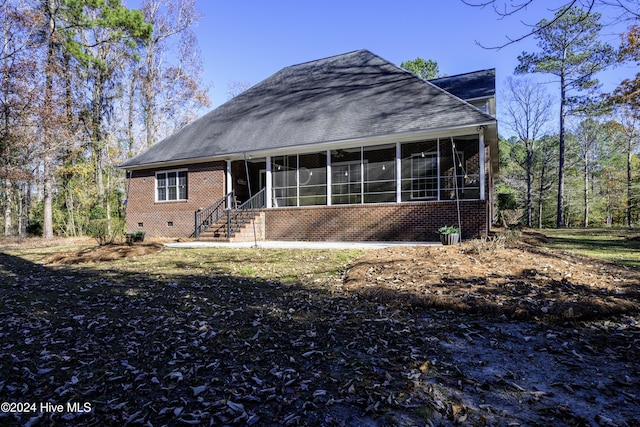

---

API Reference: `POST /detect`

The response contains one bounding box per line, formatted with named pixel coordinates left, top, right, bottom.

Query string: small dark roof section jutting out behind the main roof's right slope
left=429, top=68, right=496, bottom=100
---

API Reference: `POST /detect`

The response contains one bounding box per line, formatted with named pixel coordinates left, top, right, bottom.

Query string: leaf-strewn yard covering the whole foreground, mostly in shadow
left=0, top=239, right=640, bottom=426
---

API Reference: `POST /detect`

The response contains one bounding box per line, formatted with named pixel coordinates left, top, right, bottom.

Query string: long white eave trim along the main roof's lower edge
left=118, top=120, right=498, bottom=171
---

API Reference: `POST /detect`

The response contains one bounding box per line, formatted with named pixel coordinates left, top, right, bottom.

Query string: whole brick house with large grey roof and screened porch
left=121, top=50, right=498, bottom=241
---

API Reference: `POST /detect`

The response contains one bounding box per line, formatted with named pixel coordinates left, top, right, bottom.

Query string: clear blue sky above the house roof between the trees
left=127, top=0, right=636, bottom=122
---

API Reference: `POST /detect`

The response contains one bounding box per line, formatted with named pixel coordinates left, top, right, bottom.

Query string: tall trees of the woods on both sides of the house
left=0, top=0, right=640, bottom=238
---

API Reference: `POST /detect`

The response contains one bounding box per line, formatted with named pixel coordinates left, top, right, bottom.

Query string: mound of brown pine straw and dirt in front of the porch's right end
left=344, top=232, right=640, bottom=321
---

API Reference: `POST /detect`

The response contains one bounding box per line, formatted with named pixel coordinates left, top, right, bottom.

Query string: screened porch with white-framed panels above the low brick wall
left=258, top=134, right=484, bottom=207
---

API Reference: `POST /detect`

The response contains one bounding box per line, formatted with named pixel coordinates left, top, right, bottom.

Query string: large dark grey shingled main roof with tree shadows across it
left=121, top=50, right=495, bottom=168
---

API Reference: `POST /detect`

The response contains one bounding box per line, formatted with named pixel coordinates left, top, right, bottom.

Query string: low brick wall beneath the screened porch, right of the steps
left=265, top=200, right=488, bottom=241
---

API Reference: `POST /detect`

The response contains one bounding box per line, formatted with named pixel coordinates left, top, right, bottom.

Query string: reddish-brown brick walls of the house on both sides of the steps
left=127, top=162, right=492, bottom=241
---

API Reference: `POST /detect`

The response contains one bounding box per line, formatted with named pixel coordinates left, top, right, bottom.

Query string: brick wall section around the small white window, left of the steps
left=126, top=162, right=226, bottom=237
